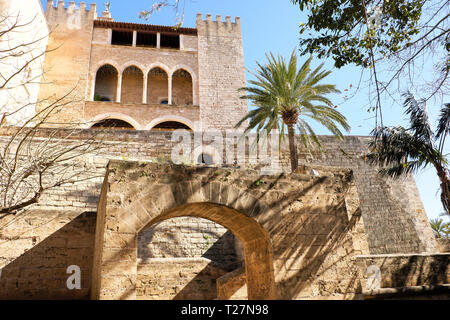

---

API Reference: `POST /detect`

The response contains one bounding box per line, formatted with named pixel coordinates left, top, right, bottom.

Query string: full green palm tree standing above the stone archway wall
left=236, top=50, right=350, bottom=172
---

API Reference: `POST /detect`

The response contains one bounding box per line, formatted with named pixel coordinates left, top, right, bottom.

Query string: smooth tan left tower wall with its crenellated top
left=38, top=1, right=97, bottom=123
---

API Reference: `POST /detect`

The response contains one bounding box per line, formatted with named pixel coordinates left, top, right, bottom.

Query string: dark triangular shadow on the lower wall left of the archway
left=0, top=212, right=96, bottom=300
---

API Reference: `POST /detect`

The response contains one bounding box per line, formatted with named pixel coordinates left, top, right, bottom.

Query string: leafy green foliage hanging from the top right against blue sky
left=291, top=0, right=425, bottom=68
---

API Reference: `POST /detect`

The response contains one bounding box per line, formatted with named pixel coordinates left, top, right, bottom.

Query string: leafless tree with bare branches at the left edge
left=0, top=13, right=104, bottom=218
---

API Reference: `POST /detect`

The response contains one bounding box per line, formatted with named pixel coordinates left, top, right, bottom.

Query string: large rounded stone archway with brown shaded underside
left=91, top=165, right=276, bottom=300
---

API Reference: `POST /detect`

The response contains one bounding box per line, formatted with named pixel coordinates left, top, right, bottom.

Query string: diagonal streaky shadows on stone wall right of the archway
left=131, top=168, right=362, bottom=299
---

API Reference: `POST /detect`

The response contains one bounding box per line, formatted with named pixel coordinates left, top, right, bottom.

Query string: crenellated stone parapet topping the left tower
left=45, top=0, right=97, bottom=29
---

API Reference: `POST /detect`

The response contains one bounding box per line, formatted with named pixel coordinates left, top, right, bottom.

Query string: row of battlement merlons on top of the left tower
left=45, top=0, right=97, bottom=21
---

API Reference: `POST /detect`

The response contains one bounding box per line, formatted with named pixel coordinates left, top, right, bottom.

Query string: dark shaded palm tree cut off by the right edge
left=368, top=92, right=450, bottom=214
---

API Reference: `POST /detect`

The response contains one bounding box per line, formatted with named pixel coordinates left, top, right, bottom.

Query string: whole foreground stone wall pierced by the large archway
left=94, top=161, right=368, bottom=299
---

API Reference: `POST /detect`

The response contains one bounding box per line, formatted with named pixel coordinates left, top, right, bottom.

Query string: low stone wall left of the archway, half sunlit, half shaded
left=0, top=210, right=96, bottom=300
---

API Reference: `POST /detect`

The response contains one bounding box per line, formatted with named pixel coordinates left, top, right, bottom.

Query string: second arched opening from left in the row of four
left=121, top=66, right=144, bottom=103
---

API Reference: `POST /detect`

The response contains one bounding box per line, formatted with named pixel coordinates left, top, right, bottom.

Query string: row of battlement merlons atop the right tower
left=197, top=13, right=242, bottom=37
